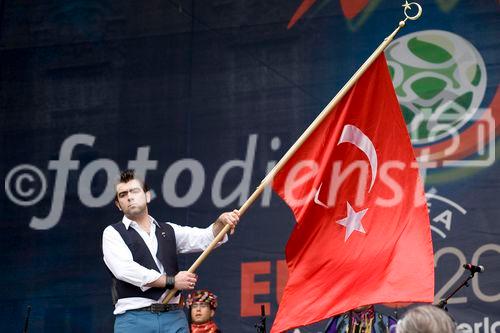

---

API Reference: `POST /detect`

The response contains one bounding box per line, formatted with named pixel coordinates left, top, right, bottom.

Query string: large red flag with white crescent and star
left=271, top=54, right=434, bottom=332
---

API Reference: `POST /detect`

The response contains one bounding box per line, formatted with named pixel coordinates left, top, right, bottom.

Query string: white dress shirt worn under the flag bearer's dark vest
left=102, top=216, right=227, bottom=315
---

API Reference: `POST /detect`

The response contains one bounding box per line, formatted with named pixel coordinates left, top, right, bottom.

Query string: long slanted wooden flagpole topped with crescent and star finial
left=163, top=0, right=422, bottom=304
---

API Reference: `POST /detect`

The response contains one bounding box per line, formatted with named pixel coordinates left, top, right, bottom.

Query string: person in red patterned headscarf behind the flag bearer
left=186, top=290, right=221, bottom=333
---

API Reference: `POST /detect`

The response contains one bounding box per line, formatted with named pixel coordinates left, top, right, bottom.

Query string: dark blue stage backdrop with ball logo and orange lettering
left=0, top=0, right=500, bottom=333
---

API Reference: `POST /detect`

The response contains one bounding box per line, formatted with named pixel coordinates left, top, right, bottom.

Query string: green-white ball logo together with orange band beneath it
left=385, top=30, right=495, bottom=167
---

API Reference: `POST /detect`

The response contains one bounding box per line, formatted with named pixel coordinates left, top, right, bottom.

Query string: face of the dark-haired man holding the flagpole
left=116, top=179, right=151, bottom=218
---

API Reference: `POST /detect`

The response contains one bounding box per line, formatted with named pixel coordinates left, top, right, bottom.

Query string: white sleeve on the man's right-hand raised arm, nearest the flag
left=168, top=222, right=228, bottom=253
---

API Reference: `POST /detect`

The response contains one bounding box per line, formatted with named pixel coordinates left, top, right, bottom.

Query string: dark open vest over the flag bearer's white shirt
left=111, top=222, right=179, bottom=304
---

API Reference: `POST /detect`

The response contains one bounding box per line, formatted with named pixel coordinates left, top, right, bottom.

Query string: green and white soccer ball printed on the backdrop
left=385, top=30, right=486, bottom=145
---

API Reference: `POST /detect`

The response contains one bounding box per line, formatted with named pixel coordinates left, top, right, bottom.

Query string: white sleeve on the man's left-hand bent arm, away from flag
left=102, top=226, right=161, bottom=291
